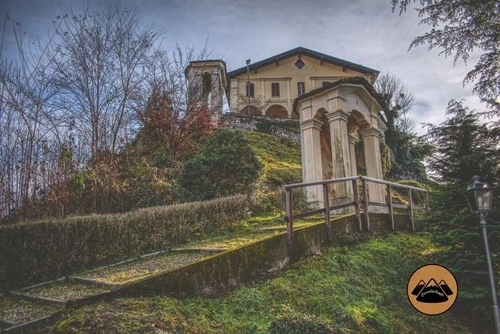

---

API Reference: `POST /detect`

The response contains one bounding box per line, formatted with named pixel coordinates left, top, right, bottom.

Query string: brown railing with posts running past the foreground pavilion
left=283, top=176, right=429, bottom=253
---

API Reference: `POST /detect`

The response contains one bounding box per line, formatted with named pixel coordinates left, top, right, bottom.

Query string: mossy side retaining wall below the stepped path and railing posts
left=115, top=214, right=411, bottom=297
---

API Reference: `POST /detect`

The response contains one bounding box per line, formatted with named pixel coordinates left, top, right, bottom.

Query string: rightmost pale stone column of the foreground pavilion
left=359, top=128, right=385, bottom=203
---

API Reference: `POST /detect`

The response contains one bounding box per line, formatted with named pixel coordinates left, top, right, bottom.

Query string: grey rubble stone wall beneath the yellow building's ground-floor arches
left=222, top=114, right=300, bottom=144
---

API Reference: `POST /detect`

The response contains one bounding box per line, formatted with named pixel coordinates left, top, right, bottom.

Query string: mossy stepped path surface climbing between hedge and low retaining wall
left=0, top=227, right=286, bottom=333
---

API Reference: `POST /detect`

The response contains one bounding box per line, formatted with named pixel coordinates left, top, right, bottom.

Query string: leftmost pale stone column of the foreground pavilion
left=300, top=118, right=323, bottom=207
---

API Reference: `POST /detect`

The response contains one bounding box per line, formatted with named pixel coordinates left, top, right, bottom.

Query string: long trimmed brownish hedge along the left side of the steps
left=0, top=195, right=247, bottom=292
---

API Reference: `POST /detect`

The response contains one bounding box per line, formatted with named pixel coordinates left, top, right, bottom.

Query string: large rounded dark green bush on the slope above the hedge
left=179, top=129, right=262, bottom=201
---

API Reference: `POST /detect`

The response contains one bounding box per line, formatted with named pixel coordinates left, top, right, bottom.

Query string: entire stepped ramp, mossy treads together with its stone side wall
left=0, top=214, right=412, bottom=333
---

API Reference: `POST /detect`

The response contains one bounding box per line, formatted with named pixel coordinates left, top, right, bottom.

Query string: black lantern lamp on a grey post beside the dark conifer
left=465, top=175, right=500, bottom=334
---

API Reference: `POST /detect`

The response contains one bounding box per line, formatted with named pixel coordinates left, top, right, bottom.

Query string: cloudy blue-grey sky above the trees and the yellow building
left=0, top=0, right=485, bottom=134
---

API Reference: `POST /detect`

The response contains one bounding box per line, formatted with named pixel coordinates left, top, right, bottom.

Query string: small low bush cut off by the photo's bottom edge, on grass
left=267, top=314, right=334, bottom=334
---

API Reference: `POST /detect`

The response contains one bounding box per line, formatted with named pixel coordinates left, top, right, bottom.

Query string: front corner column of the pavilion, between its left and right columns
left=325, top=109, right=352, bottom=198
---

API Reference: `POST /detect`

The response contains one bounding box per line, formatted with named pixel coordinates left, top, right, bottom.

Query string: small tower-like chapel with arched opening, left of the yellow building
left=185, top=60, right=227, bottom=122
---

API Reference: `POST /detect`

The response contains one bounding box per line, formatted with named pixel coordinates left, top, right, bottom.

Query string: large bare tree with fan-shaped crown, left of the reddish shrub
left=54, top=7, right=164, bottom=158
